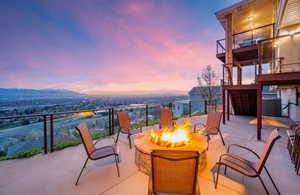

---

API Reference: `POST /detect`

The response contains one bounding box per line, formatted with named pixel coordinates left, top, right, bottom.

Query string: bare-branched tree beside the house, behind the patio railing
left=197, top=65, right=217, bottom=104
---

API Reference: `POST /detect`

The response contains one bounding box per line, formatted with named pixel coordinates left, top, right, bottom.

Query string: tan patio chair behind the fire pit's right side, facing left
left=194, top=112, right=225, bottom=150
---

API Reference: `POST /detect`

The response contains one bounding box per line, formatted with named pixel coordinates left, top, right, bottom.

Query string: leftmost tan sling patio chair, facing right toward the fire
left=75, top=123, right=120, bottom=185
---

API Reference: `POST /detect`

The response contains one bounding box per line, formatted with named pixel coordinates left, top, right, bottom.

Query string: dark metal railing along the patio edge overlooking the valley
left=0, top=100, right=219, bottom=160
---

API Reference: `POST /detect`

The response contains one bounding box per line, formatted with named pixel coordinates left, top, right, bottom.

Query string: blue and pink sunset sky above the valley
left=0, top=0, right=237, bottom=93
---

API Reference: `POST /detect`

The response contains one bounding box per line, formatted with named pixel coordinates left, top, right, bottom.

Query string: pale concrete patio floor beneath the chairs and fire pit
left=0, top=116, right=300, bottom=195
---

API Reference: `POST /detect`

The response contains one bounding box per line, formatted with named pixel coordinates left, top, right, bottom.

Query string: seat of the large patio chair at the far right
left=221, top=153, right=257, bottom=177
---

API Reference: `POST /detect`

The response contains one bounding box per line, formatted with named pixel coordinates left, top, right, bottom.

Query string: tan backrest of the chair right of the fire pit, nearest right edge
left=255, top=129, right=280, bottom=173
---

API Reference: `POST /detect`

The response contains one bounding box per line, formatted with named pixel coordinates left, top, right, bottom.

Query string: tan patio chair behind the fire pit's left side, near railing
left=116, top=111, right=142, bottom=149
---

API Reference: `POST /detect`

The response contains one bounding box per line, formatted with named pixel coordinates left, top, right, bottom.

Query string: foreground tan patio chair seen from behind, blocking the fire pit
left=148, top=150, right=200, bottom=195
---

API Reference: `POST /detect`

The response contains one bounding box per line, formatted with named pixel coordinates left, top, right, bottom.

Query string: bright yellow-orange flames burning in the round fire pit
left=150, top=120, right=191, bottom=147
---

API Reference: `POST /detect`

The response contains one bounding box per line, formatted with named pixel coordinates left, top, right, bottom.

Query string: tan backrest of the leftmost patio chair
left=76, top=123, right=95, bottom=156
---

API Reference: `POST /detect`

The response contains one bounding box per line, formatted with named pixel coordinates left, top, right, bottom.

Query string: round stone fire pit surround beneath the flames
left=134, top=131, right=207, bottom=175
